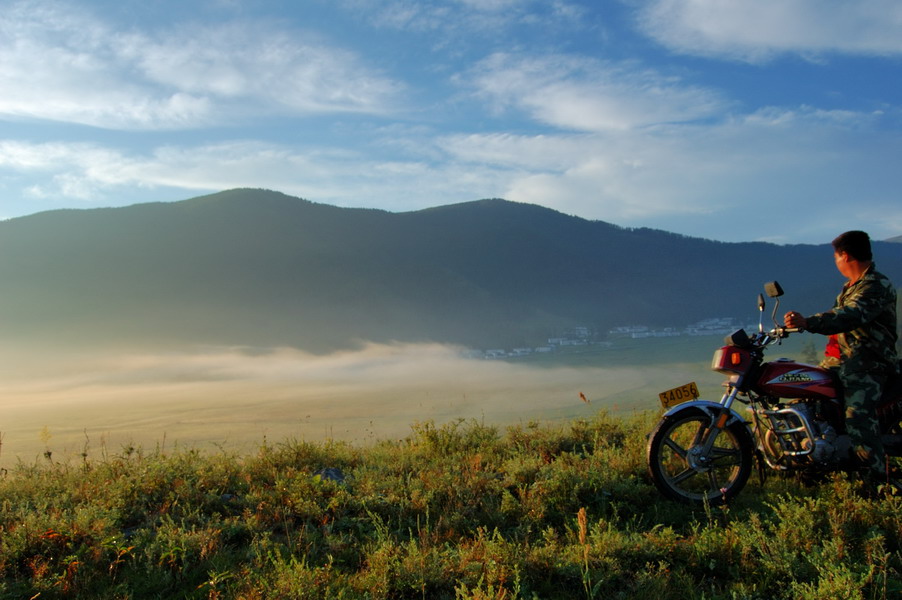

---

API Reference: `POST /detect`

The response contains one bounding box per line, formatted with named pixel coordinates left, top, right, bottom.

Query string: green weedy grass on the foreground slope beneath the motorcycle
left=0, top=412, right=902, bottom=600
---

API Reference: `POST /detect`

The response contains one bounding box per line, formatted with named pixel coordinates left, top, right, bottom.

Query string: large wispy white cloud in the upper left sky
left=0, top=2, right=400, bottom=129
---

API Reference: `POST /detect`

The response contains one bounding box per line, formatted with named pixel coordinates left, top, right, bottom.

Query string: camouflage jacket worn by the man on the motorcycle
left=807, top=263, right=898, bottom=374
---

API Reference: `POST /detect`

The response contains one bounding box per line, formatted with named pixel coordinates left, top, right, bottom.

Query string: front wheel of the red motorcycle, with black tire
left=648, top=408, right=754, bottom=506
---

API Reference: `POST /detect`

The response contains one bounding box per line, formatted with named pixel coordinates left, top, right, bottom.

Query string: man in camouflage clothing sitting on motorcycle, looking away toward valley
left=784, top=231, right=898, bottom=482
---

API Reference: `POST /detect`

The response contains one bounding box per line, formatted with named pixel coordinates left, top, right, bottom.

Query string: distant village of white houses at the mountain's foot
left=467, top=317, right=758, bottom=359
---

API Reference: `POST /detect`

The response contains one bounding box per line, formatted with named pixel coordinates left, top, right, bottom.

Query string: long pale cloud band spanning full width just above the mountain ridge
left=7, top=97, right=902, bottom=241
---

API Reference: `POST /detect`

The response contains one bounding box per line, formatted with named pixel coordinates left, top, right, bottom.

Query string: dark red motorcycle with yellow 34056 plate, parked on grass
left=647, top=281, right=902, bottom=506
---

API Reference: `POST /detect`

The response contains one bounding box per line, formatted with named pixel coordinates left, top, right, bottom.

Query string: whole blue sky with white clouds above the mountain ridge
left=0, top=0, right=902, bottom=243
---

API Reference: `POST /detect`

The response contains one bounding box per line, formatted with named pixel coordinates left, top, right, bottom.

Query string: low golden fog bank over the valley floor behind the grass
left=0, top=344, right=708, bottom=466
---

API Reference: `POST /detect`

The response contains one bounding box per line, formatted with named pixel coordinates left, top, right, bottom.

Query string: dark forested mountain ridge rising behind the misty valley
left=0, top=190, right=902, bottom=352
